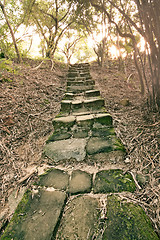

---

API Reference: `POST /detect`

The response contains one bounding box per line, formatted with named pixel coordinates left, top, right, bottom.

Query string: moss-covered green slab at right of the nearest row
left=101, top=195, right=159, bottom=240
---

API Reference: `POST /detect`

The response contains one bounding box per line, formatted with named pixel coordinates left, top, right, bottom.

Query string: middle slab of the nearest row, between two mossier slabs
left=57, top=196, right=100, bottom=240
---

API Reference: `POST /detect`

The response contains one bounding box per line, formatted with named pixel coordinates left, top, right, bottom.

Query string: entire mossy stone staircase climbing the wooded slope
left=1, top=64, right=159, bottom=240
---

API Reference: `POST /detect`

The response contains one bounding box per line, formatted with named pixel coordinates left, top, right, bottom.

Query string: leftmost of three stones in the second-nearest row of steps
left=38, top=168, right=69, bottom=190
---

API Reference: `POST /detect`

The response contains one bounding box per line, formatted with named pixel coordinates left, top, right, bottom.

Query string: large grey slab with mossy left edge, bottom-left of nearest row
left=1, top=190, right=66, bottom=240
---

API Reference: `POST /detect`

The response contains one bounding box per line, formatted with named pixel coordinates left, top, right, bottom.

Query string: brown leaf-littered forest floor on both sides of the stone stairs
left=0, top=59, right=160, bottom=236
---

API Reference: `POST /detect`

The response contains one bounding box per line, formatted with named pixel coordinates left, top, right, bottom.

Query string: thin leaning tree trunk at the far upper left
left=0, top=2, right=21, bottom=62
